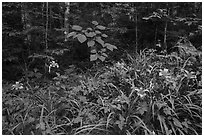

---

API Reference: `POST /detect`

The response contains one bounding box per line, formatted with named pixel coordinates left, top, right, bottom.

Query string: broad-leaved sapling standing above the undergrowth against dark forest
left=67, top=21, right=117, bottom=61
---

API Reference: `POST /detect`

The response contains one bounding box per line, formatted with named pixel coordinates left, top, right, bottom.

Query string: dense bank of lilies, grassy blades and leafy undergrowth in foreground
left=2, top=49, right=202, bottom=135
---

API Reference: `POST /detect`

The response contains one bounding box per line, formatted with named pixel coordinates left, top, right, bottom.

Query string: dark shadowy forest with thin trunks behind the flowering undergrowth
left=2, top=2, right=202, bottom=80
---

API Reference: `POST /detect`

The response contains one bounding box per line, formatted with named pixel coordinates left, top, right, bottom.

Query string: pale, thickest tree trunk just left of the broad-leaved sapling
left=64, top=2, right=70, bottom=41
